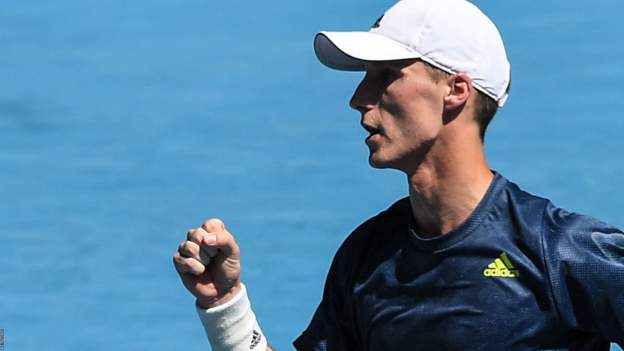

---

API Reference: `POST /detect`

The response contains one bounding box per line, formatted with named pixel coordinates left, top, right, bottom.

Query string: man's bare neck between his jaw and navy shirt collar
left=407, top=133, right=494, bottom=237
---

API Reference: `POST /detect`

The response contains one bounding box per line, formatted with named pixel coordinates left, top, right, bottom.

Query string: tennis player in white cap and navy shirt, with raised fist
left=174, top=0, right=624, bottom=351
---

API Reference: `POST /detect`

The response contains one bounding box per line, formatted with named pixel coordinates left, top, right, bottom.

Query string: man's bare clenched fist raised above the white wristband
left=173, top=218, right=241, bottom=308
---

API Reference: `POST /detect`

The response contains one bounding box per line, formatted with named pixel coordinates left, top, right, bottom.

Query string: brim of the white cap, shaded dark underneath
left=314, top=32, right=422, bottom=71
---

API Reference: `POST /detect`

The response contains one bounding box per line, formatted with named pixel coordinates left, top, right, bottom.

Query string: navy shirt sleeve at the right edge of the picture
left=544, top=210, right=624, bottom=349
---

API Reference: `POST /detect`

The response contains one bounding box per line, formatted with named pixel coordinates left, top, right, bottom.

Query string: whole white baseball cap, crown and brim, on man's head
left=314, top=0, right=511, bottom=106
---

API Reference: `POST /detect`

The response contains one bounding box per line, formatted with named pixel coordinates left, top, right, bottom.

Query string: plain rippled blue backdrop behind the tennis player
left=0, top=0, right=624, bottom=351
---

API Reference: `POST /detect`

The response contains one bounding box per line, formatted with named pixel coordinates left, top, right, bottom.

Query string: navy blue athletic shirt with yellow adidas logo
left=294, top=174, right=624, bottom=351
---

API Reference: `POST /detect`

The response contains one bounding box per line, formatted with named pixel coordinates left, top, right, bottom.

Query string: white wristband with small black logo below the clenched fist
left=196, top=284, right=267, bottom=351
